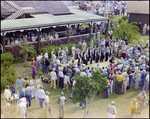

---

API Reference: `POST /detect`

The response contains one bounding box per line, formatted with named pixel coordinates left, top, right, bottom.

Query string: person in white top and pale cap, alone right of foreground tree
left=106, top=101, right=117, bottom=118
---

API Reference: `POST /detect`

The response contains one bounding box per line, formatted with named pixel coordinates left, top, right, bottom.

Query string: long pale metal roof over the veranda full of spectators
left=1, top=7, right=109, bottom=32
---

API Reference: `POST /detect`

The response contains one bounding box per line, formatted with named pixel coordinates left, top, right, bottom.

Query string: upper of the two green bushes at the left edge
left=1, top=52, right=14, bottom=64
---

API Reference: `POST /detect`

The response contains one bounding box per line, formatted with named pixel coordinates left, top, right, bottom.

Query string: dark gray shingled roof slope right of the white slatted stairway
left=12, top=1, right=70, bottom=14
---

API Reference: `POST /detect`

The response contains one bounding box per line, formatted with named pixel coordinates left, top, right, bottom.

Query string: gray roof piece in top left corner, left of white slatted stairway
left=1, top=1, right=18, bottom=13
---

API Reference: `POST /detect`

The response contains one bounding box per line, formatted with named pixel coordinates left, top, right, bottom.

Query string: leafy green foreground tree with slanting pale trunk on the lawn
left=72, top=71, right=107, bottom=118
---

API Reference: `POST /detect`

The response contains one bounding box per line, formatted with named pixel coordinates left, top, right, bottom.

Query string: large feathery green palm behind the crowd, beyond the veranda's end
left=111, top=19, right=141, bottom=43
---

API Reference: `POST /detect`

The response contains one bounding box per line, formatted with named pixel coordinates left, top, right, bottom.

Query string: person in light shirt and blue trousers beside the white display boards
left=25, top=84, right=32, bottom=107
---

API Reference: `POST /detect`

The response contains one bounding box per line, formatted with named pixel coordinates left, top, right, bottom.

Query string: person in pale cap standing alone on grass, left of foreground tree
left=58, top=92, right=67, bottom=118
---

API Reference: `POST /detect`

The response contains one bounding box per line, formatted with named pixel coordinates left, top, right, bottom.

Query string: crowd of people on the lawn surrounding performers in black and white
left=4, top=34, right=149, bottom=117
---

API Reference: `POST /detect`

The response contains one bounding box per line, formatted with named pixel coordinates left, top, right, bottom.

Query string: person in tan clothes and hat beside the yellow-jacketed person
left=137, top=91, right=147, bottom=114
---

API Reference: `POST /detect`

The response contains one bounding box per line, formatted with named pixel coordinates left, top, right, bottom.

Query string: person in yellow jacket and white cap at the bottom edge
left=129, top=99, right=138, bottom=118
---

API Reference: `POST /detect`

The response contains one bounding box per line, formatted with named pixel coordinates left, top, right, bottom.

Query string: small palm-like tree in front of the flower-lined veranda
left=18, top=43, right=36, bottom=63
